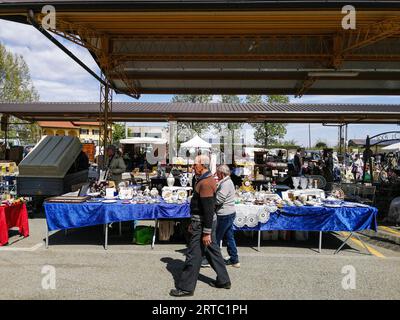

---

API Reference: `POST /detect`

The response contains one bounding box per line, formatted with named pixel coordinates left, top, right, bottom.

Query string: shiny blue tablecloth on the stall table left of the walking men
left=44, top=201, right=190, bottom=231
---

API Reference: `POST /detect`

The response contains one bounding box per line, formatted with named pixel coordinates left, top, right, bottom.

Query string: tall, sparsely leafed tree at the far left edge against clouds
left=0, top=43, right=40, bottom=143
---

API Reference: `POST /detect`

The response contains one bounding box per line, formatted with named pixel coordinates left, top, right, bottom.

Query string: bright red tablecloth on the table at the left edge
left=0, top=203, right=29, bottom=246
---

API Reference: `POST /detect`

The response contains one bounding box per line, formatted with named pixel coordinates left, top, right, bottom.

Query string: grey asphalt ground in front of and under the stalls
left=0, top=218, right=400, bottom=300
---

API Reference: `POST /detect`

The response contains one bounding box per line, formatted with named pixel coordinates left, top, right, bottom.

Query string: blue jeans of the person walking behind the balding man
left=216, top=213, right=239, bottom=263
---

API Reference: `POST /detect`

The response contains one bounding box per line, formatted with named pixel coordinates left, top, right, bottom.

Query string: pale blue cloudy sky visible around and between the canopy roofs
left=0, top=20, right=400, bottom=146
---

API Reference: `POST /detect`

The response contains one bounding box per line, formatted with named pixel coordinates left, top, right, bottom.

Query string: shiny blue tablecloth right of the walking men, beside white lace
left=234, top=206, right=378, bottom=231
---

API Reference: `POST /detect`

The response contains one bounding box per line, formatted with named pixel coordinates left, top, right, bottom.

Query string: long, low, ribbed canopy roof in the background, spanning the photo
left=0, top=102, right=400, bottom=123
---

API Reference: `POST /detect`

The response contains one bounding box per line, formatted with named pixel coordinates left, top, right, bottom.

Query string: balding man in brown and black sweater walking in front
left=170, top=155, right=231, bottom=297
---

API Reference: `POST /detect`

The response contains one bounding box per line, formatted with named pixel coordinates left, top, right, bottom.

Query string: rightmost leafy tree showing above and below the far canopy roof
left=246, top=95, right=289, bottom=148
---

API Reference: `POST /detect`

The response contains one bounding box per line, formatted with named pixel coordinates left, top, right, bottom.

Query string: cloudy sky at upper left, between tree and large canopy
left=0, top=20, right=99, bottom=101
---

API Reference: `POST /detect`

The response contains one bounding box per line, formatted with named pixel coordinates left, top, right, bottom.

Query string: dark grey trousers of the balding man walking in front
left=177, top=221, right=230, bottom=291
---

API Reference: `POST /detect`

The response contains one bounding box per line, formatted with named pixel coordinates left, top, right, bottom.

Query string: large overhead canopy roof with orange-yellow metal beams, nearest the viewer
left=0, top=0, right=400, bottom=97
